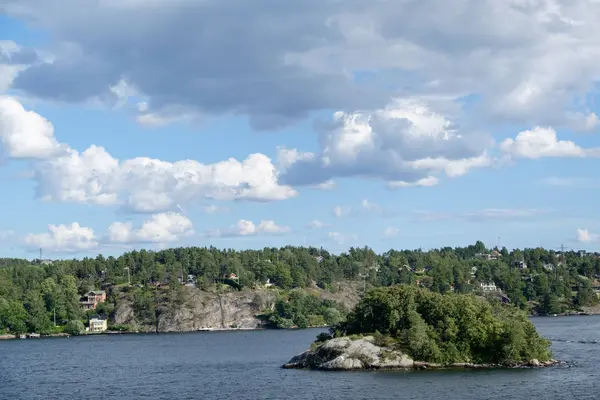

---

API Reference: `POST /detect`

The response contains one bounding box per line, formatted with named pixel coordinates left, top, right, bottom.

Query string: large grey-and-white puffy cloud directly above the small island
left=281, top=98, right=493, bottom=187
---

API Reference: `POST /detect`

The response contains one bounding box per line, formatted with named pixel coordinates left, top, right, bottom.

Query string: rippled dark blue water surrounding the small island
left=0, top=316, right=600, bottom=400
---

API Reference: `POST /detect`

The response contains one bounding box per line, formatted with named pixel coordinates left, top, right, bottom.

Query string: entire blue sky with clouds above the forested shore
left=0, top=0, right=600, bottom=258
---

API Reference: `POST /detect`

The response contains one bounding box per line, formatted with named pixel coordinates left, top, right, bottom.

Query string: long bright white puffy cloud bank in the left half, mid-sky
left=34, top=146, right=297, bottom=212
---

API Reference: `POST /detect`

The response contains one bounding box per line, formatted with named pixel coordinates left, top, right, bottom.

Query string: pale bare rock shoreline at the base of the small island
left=282, top=336, right=561, bottom=371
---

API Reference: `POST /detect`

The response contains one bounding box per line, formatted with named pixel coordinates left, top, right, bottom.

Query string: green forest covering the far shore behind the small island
left=0, top=242, right=600, bottom=333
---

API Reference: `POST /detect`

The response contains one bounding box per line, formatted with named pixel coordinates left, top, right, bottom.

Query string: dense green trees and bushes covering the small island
left=333, top=285, right=550, bottom=364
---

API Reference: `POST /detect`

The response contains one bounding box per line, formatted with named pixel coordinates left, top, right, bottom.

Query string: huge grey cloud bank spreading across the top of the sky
left=3, top=0, right=600, bottom=129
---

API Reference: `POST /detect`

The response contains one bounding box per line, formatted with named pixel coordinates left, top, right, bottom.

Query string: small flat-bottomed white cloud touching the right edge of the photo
left=500, top=127, right=600, bottom=159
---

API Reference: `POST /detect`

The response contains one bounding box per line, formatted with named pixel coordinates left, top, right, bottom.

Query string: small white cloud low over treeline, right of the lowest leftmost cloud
left=107, top=212, right=194, bottom=243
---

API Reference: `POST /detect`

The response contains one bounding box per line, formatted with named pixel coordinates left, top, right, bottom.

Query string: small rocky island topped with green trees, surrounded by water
left=283, top=285, right=559, bottom=371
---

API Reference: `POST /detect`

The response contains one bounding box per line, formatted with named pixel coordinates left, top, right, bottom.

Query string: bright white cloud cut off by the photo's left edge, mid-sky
left=0, top=95, right=65, bottom=158
